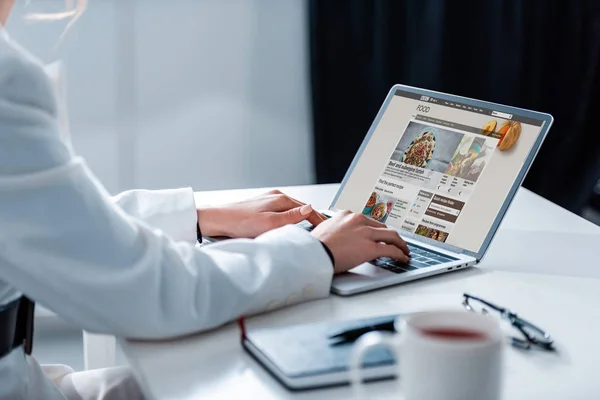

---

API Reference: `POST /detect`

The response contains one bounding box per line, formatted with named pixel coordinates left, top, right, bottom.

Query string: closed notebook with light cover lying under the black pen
left=243, top=316, right=396, bottom=390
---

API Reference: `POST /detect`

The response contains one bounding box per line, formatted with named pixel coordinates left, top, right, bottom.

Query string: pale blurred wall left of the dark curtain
left=8, top=0, right=313, bottom=192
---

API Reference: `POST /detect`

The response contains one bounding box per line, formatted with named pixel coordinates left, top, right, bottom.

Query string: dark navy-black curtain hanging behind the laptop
left=309, top=0, right=600, bottom=211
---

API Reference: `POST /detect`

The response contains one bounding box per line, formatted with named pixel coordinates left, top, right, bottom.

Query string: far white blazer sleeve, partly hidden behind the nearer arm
left=112, top=188, right=198, bottom=243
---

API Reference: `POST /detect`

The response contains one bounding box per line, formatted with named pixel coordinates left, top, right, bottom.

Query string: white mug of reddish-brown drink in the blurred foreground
left=350, top=311, right=504, bottom=400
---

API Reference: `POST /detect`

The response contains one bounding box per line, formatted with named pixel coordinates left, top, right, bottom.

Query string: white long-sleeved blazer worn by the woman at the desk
left=0, top=28, right=333, bottom=399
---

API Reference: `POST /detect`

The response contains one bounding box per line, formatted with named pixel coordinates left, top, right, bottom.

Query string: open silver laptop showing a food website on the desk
left=302, top=85, right=553, bottom=296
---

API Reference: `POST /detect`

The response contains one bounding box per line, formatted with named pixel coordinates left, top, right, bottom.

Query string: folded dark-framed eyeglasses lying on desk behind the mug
left=463, top=293, right=554, bottom=351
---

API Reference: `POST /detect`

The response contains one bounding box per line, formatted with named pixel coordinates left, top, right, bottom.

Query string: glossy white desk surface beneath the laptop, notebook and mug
left=122, top=185, right=600, bottom=400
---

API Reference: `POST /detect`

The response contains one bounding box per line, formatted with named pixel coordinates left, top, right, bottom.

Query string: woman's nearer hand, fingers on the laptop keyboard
left=312, top=211, right=410, bottom=274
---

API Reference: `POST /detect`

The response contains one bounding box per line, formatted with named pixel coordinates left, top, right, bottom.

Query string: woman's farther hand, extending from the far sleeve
left=198, top=190, right=327, bottom=238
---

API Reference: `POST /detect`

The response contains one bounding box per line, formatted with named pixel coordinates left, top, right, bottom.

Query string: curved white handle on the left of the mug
left=349, top=332, right=400, bottom=400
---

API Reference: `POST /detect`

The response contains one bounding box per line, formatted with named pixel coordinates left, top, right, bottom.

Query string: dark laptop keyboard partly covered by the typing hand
left=298, top=221, right=457, bottom=274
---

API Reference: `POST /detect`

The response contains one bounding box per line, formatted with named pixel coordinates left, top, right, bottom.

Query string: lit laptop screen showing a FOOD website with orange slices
left=334, top=90, right=543, bottom=252
